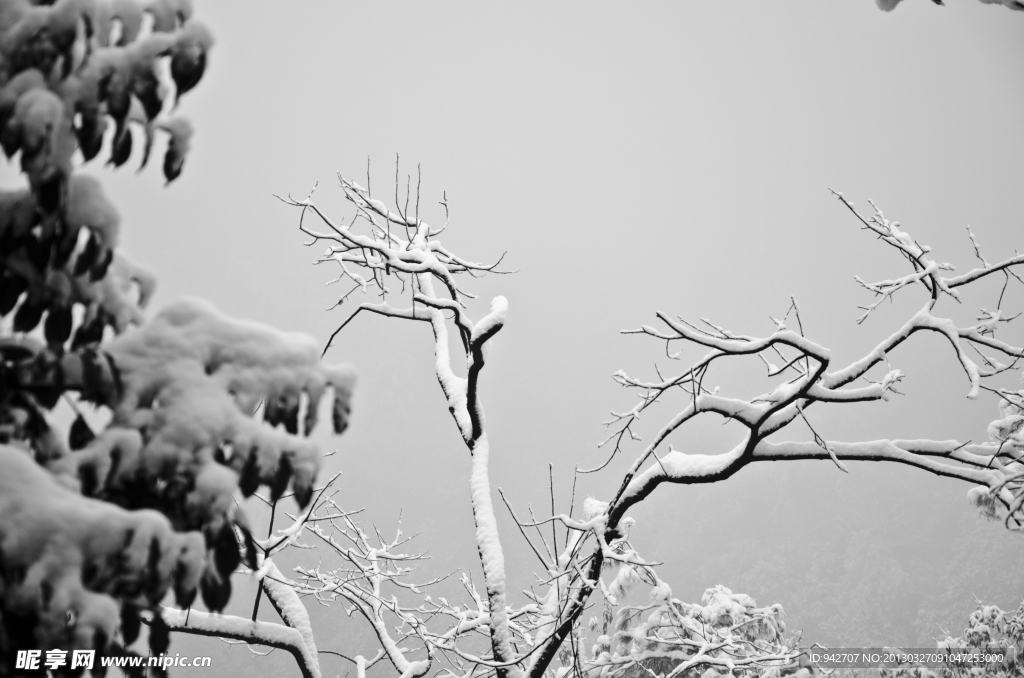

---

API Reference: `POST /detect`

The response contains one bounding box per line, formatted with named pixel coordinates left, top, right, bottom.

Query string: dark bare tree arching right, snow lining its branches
left=507, top=196, right=1024, bottom=678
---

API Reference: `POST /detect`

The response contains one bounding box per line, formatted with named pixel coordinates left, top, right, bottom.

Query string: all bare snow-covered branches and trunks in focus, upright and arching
left=268, top=175, right=1024, bottom=678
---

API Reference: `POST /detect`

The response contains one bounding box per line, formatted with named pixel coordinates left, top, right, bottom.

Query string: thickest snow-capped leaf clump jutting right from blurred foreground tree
left=53, top=300, right=354, bottom=528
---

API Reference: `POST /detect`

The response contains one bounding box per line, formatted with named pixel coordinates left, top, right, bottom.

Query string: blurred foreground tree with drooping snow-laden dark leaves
left=0, top=0, right=352, bottom=675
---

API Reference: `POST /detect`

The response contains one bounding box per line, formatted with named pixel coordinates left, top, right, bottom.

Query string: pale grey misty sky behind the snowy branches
left=2, top=0, right=1024, bottom=676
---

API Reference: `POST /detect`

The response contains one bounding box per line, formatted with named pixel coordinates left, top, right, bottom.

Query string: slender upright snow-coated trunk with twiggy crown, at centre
left=282, top=166, right=517, bottom=678
